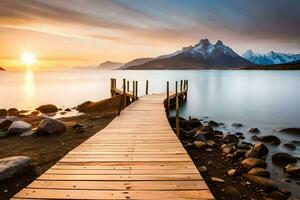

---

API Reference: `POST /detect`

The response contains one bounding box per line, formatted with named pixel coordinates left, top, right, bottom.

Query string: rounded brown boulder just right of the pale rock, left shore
left=36, top=118, right=67, bottom=135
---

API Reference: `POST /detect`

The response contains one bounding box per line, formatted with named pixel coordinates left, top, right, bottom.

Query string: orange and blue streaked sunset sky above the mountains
left=0, top=0, right=300, bottom=70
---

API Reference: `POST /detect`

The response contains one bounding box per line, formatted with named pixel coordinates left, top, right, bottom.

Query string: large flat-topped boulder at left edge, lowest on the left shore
left=0, top=156, right=32, bottom=182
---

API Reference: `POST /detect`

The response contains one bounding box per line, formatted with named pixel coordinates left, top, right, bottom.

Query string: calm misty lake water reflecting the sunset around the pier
left=0, top=70, right=300, bottom=196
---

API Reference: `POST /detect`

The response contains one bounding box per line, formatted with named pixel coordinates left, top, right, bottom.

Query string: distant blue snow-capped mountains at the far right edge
left=242, top=49, right=300, bottom=65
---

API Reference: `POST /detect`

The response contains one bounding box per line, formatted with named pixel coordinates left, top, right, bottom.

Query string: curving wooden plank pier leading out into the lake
left=13, top=81, right=214, bottom=200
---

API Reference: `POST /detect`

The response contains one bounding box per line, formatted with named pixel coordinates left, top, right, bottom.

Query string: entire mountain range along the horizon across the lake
left=98, top=39, right=300, bottom=70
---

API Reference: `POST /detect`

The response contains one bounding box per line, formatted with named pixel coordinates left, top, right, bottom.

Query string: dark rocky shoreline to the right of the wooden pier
left=169, top=117, right=300, bottom=200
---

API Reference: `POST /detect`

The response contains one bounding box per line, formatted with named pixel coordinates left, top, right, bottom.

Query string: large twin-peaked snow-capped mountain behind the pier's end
left=122, top=39, right=253, bottom=69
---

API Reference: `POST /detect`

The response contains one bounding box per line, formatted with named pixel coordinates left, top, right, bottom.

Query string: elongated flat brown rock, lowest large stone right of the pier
left=243, top=174, right=278, bottom=192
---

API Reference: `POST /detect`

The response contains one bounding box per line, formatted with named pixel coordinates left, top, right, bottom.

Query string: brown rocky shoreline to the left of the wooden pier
left=0, top=100, right=119, bottom=199
